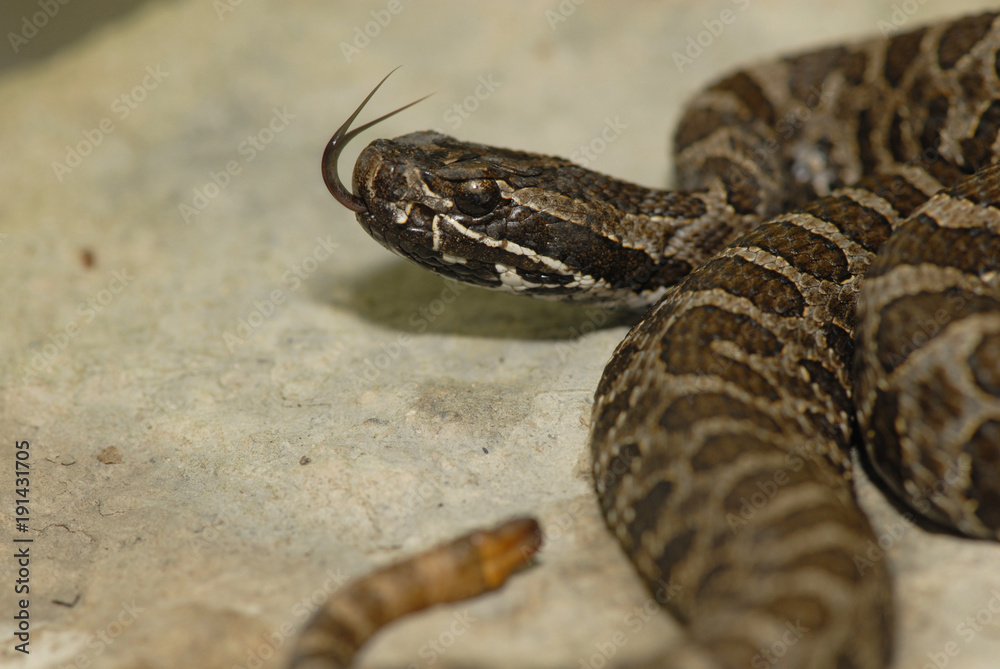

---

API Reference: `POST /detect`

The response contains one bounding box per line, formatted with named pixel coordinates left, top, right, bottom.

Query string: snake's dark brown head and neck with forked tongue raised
left=322, top=73, right=730, bottom=308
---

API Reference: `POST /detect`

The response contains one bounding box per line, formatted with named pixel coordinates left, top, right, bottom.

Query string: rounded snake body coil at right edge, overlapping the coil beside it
left=855, top=167, right=1000, bottom=538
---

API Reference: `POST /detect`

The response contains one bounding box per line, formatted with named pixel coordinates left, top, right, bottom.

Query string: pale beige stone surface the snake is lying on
left=0, top=0, right=1000, bottom=669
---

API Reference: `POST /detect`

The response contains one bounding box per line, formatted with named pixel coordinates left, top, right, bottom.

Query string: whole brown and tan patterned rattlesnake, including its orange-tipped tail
left=295, top=13, right=1000, bottom=669
